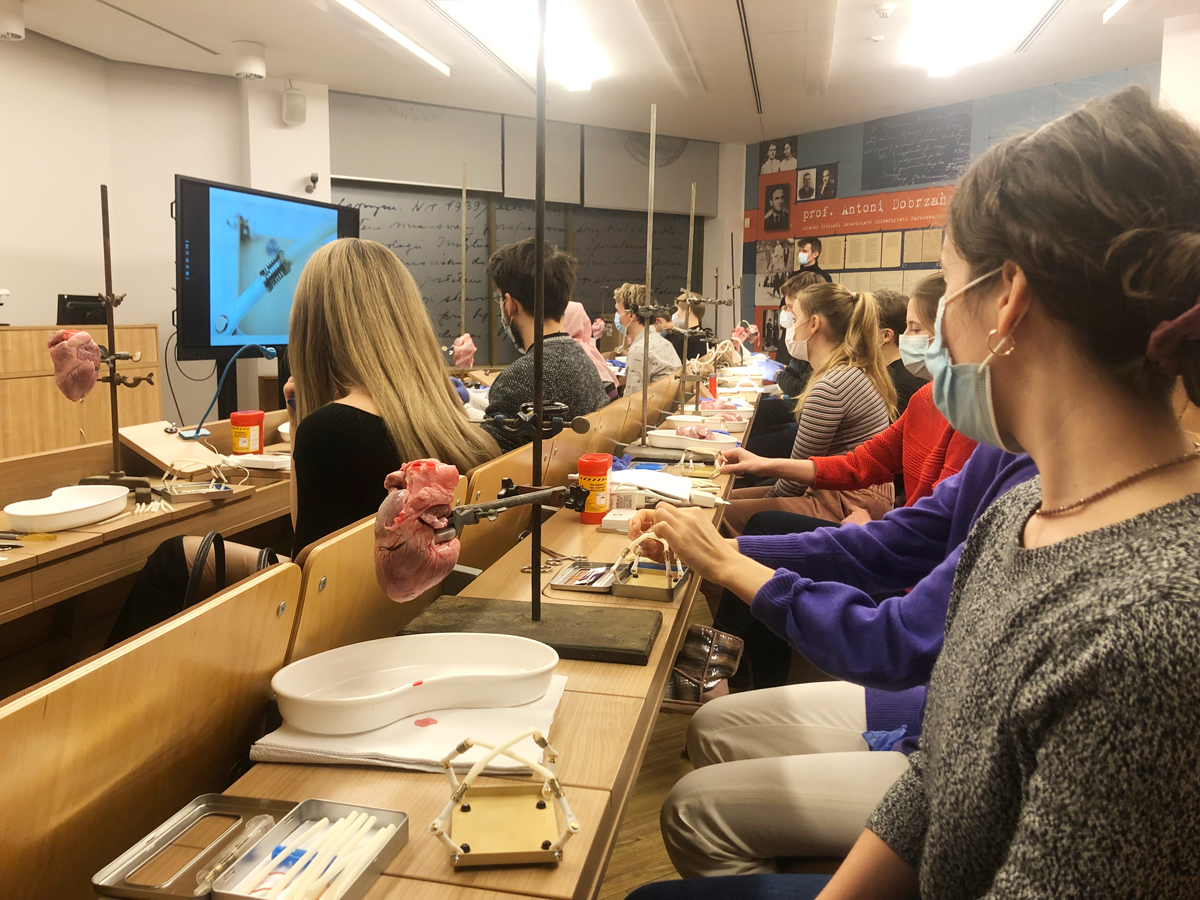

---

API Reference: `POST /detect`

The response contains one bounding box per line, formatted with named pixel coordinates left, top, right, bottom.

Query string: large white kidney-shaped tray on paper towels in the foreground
left=271, top=634, right=558, bottom=734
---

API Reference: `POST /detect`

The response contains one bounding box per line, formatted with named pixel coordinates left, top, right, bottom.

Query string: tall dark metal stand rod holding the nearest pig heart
left=529, top=0, right=546, bottom=622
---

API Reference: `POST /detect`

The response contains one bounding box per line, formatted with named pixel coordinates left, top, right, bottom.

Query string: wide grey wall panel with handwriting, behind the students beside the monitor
left=332, top=181, right=688, bottom=365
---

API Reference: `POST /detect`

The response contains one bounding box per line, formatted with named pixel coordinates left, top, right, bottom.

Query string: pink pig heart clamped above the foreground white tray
left=374, top=460, right=460, bottom=604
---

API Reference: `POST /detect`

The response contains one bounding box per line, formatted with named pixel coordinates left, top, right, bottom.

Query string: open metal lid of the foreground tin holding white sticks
left=91, top=793, right=296, bottom=900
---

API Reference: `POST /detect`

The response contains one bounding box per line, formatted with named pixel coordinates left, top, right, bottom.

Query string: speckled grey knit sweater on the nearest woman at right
left=868, top=479, right=1200, bottom=900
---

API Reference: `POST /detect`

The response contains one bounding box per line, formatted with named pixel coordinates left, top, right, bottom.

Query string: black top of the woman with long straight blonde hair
left=292, top=403, right=402, bottom=559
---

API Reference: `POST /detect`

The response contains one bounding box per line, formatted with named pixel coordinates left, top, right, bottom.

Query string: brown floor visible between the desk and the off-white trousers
left=598, top=596, right=713, bottom=900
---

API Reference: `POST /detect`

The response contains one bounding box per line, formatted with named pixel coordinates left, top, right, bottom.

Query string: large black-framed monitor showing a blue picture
left=175, top=175, right=359, bottom=359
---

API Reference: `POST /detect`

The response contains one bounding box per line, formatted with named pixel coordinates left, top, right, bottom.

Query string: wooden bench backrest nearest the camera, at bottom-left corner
left=0, top=563, right=300, bottom=900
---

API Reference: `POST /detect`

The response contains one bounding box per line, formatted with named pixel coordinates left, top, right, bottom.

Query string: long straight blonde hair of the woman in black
left=288, top=238, right=500, bottom=473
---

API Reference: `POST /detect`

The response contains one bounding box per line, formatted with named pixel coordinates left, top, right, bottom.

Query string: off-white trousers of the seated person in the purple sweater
left=660, top=682, right=908, bottom=878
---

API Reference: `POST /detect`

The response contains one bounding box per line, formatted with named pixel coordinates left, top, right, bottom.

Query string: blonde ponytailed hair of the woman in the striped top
left=796, top=282, right=896, bottom=421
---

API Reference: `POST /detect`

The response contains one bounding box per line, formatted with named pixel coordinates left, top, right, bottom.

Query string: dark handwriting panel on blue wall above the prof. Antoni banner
left=863, top=102, right=971, bottom=191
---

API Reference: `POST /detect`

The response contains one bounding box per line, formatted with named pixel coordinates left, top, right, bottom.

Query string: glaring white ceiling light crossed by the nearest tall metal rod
left=438, top=0, right=610, bottom=91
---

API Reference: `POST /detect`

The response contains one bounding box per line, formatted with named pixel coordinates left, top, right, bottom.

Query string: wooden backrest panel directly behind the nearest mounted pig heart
left=287, top=475, right=465, bottom=662
